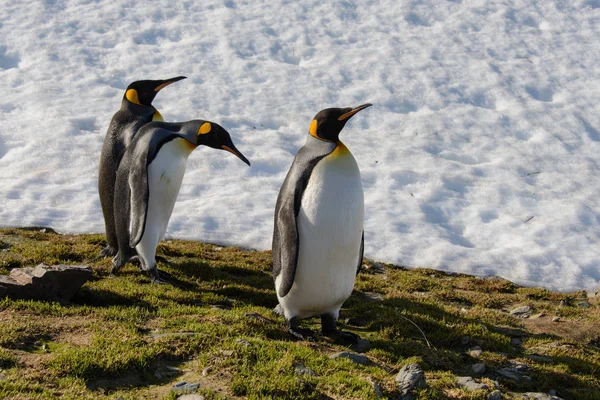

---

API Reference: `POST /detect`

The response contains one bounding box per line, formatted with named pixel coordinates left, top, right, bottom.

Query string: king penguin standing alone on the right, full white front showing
left=273, top=104, right=371, bottom=341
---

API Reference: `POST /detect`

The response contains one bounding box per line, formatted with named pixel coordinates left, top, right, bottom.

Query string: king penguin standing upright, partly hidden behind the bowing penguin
left=98, top=76, right=185, bottom=257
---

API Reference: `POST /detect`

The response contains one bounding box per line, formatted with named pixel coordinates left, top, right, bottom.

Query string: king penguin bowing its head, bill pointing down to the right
left=111, top=120, right=250, bottom=283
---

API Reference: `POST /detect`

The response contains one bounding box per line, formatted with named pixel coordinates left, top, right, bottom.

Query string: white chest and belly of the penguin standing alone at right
left=279, top=148, right=364, bottom=318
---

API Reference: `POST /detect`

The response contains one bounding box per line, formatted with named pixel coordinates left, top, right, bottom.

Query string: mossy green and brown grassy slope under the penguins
left=0, top=229, right=600, bottom=399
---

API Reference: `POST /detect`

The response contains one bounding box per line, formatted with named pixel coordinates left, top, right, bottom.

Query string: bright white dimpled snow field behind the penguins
left=0, top=0, right=600, bottom=290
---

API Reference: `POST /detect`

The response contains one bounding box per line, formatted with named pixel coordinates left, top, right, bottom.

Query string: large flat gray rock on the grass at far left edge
left=0, top=264, right=93, bottom=302
